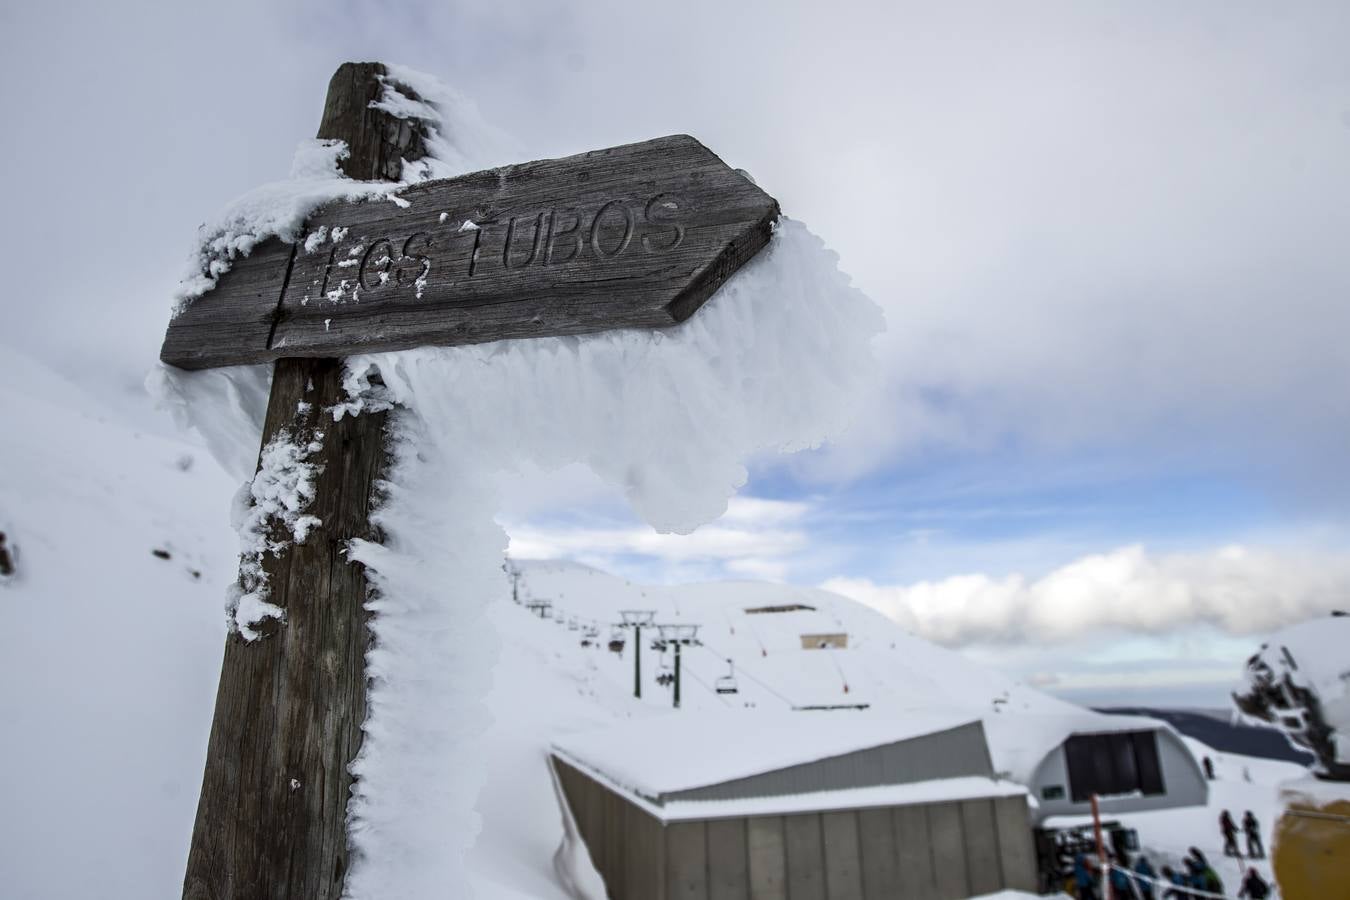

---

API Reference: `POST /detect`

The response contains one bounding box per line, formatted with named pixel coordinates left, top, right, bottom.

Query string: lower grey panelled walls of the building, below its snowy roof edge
left=555, top=760, right=1035, bottom=900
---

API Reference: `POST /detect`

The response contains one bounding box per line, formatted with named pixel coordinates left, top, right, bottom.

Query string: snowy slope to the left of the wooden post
left=0, top=348, right=238, bottom=900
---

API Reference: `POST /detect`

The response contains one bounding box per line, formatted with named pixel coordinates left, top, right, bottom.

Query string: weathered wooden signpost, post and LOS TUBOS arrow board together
left=161, top=63, right=779, bottom=900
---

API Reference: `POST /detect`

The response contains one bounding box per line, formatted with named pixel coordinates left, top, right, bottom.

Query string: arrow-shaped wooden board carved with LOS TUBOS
left=161, top=135, right=779, bottom=368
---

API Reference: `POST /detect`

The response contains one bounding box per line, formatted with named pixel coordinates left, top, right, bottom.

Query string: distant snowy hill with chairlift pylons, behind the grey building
left=517, top=561, right=1079, bottom=715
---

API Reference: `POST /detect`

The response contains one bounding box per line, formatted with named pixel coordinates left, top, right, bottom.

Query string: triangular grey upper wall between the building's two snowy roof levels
left=662, top=721, right=994, bottom=801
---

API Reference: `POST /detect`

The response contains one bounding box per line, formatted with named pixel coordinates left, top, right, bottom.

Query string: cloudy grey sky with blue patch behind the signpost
left=0, top=0, right=1350, bottom=704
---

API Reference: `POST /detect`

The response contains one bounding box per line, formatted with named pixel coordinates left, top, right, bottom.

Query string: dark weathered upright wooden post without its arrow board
left=184, top=63, right=420, bottom=900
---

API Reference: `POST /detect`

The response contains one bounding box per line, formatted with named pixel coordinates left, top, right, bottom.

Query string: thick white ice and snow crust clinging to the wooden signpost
left=150, top=67, right=884, bottom=900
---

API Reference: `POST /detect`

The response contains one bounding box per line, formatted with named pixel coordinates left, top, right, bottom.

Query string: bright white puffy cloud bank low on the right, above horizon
left=822, top=545, right=1350, bottom=645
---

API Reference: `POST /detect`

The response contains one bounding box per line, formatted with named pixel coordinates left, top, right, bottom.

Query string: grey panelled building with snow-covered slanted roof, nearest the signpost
left=552, top=712, right=1035, bottom=900
